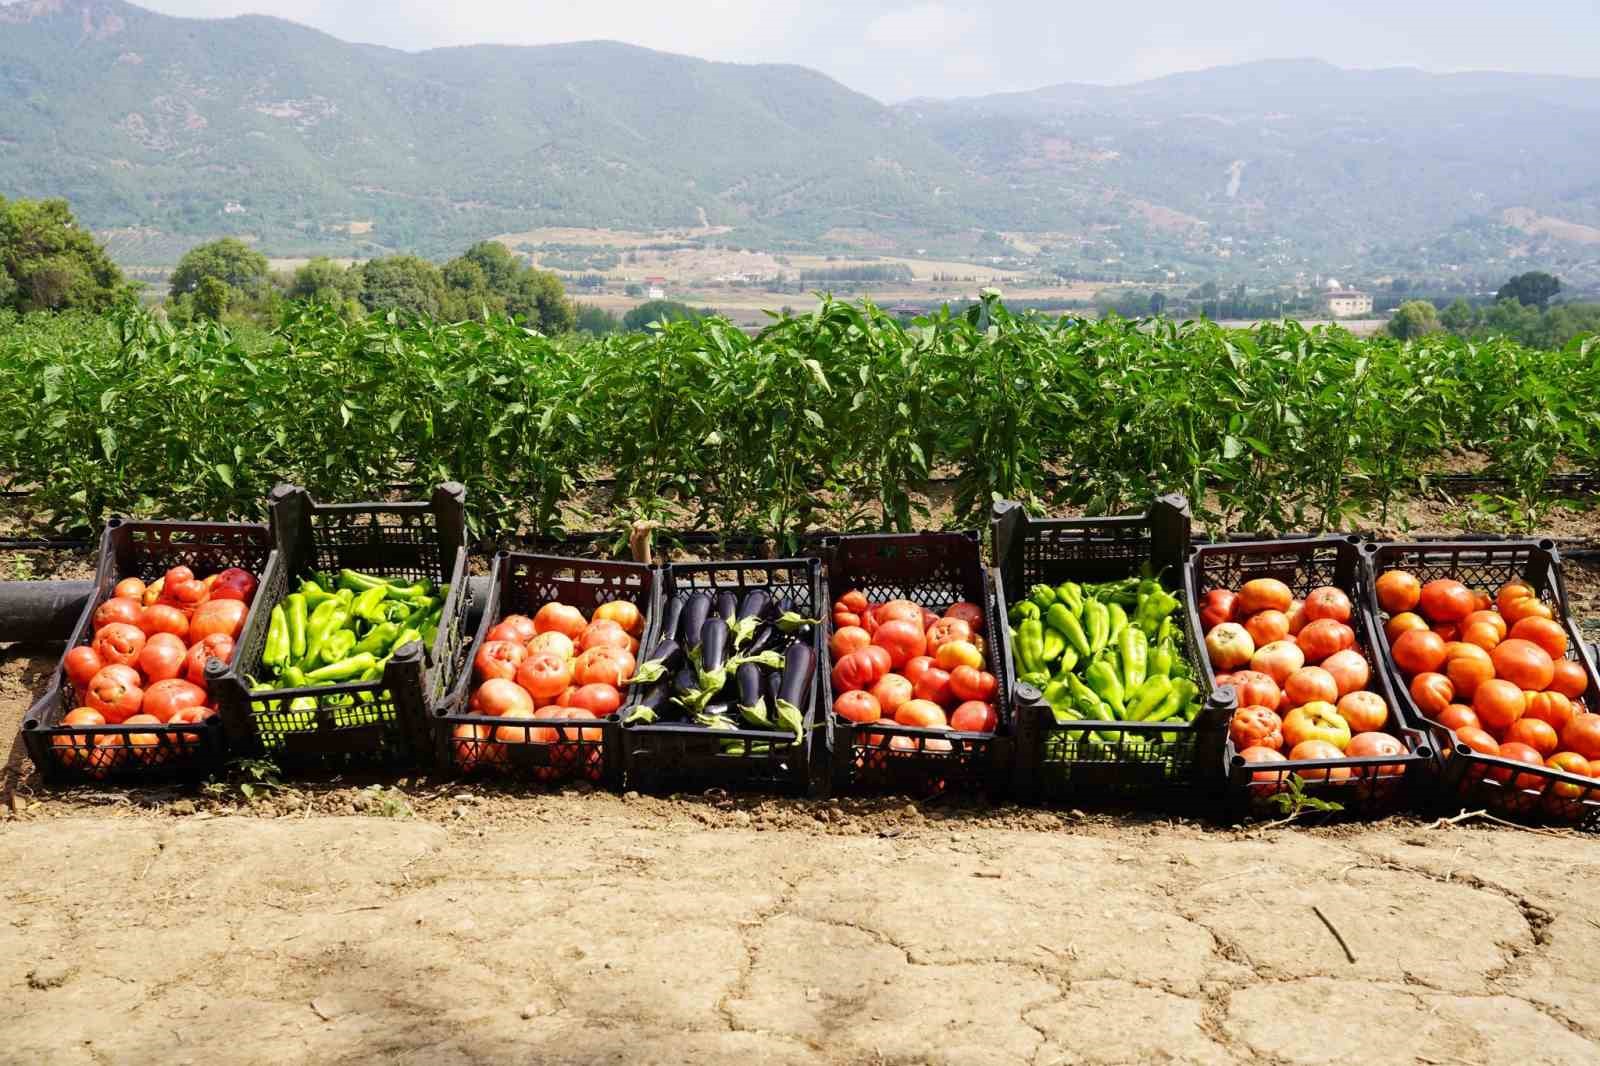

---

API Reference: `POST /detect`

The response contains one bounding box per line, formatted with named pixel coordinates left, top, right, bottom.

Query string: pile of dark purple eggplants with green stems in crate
left=626, top=589, right=819, bottom=741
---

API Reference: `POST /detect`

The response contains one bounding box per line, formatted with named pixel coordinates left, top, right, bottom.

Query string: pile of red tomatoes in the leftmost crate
left=51, top=567, right=256, bottom=776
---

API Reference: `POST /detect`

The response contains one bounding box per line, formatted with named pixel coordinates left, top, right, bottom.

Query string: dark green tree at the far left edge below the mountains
left=0, top=197, right=128, bottom=312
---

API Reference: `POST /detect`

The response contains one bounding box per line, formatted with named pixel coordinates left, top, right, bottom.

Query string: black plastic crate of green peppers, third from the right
left=994, top=495, right=1234, bottom=800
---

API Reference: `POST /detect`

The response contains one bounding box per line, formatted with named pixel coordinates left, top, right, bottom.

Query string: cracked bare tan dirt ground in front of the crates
left=0, top=515, right=1600, bottom=1066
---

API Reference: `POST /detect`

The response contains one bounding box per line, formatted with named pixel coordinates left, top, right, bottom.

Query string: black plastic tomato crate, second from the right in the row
left=1184, top=536, right=1434, bottom=818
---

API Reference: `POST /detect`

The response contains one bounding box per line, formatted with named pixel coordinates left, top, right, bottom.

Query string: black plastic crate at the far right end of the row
left=1362, top=539, right=1600, bottom=829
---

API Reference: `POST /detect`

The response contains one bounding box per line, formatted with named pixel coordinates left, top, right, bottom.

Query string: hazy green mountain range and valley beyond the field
left=0, top=0, right=1600, bottom=274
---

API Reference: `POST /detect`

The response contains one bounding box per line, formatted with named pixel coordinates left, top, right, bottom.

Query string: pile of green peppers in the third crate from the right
left=1011, top=578, right=1200, bottom=743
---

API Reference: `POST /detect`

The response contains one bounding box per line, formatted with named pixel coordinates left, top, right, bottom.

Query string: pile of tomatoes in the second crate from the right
left=1200, top=578, right=1405, bottom=784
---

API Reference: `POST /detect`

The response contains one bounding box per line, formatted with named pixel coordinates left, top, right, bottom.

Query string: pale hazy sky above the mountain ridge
left=136, top=0, right=1600, bottom=101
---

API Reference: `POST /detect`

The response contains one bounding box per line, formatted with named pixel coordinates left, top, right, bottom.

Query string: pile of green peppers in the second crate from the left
left=253, top=570, right=450, bottom=697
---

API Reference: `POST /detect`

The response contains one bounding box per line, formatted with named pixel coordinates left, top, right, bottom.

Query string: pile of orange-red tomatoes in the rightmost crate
left=1374, top=570, right=1600, bottom=795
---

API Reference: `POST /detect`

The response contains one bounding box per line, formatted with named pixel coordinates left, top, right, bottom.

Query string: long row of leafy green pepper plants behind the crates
left=0, top=298, right=1600, bottom=546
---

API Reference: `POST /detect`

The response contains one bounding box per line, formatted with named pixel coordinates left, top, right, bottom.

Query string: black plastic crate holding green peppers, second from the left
left=213, top=483, right=470, bottom=771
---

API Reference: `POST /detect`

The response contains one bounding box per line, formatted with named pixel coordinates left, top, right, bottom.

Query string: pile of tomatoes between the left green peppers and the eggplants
left=453, top=600, right=645, bottom=778
